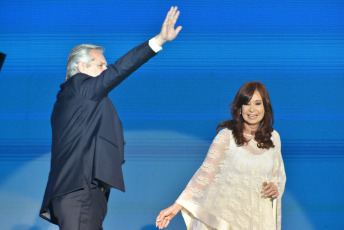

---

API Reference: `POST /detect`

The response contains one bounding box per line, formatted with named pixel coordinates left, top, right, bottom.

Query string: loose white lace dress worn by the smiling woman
left=176, top=129, right=286, bottom=230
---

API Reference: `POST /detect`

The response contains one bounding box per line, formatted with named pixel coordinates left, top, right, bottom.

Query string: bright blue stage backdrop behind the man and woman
left=0, top=0, right=344, bottom=230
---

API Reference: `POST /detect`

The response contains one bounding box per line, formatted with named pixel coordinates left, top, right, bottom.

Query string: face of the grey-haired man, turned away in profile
left=79, top=50, right=107, bottom=77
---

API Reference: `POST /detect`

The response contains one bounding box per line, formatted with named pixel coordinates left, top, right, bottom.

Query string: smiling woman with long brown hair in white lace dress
left=156, top=82, right=286, bottom=230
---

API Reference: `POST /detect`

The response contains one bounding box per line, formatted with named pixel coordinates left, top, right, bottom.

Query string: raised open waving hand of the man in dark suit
left=155, top=6, right=182, bottom=46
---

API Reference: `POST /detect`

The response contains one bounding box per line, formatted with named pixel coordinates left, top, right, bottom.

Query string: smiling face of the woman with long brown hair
left=241, top=90, right=265, bottom=131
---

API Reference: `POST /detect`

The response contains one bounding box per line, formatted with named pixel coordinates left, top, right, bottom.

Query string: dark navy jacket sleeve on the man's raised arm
left=80, top=41, right=156, bottom=100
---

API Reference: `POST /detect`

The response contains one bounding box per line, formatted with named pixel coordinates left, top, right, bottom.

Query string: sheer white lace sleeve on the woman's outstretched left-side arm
left=177, top=129, right=230, bottom=203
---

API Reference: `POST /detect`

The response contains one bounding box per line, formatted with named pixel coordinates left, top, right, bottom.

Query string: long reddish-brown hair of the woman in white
left=216, top=81, right=275, bottom=149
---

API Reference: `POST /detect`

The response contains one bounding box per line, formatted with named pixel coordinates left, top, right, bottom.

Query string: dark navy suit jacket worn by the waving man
left=40, top=41, right=156, bottom=224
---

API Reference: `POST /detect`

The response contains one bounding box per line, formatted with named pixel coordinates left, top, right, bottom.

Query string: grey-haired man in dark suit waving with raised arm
left=40, top=7, right=181, bottom=230
